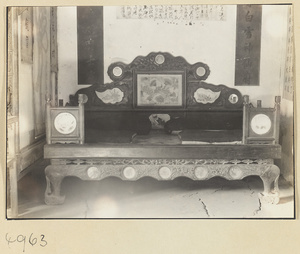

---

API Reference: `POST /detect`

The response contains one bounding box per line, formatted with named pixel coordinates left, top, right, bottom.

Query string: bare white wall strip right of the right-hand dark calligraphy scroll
left=247, top=5, right=288, bottom=107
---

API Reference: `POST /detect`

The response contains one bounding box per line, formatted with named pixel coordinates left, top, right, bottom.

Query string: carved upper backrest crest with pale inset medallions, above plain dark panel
left=70, top=52, right=243, bottom=112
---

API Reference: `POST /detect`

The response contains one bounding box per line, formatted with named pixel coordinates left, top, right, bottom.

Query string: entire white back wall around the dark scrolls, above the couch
left=58, top=5, right=287, bottom=107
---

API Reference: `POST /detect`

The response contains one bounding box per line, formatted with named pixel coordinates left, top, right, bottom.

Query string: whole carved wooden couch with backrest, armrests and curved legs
left=44, top=52, right=281, bottom=205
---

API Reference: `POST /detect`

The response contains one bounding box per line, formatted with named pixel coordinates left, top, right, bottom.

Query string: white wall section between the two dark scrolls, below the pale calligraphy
left=104, top=5, right=236, bottom=85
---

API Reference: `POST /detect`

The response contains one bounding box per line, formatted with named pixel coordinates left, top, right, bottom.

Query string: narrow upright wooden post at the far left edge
left=6, top=7, right=20, bottom=218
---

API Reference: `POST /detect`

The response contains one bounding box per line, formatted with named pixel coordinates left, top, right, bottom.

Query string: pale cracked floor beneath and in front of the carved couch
left=7, top=160, right=294, bottom=219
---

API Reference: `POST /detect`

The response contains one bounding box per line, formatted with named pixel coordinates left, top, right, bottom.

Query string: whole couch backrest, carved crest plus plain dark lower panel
left=70, top=52, right=243, bottom=136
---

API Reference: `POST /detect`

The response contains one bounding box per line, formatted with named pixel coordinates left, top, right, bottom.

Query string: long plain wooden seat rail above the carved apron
left=44, top=144, right=281, bottom=159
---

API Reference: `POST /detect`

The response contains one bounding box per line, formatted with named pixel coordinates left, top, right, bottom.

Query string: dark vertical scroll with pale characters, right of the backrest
left=235, top=4, right=262, bottom=86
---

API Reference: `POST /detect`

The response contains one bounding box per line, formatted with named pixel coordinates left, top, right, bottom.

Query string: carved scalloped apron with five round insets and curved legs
left=45, top=158, right=280, bottom=205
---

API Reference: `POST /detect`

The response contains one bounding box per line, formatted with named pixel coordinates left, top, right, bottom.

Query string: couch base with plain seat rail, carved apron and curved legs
left=44, top=144, right=281, bottom=205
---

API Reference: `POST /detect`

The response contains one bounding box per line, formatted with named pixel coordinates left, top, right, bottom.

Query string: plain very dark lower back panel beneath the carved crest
left=85, top=111, right=243, bottom=132
